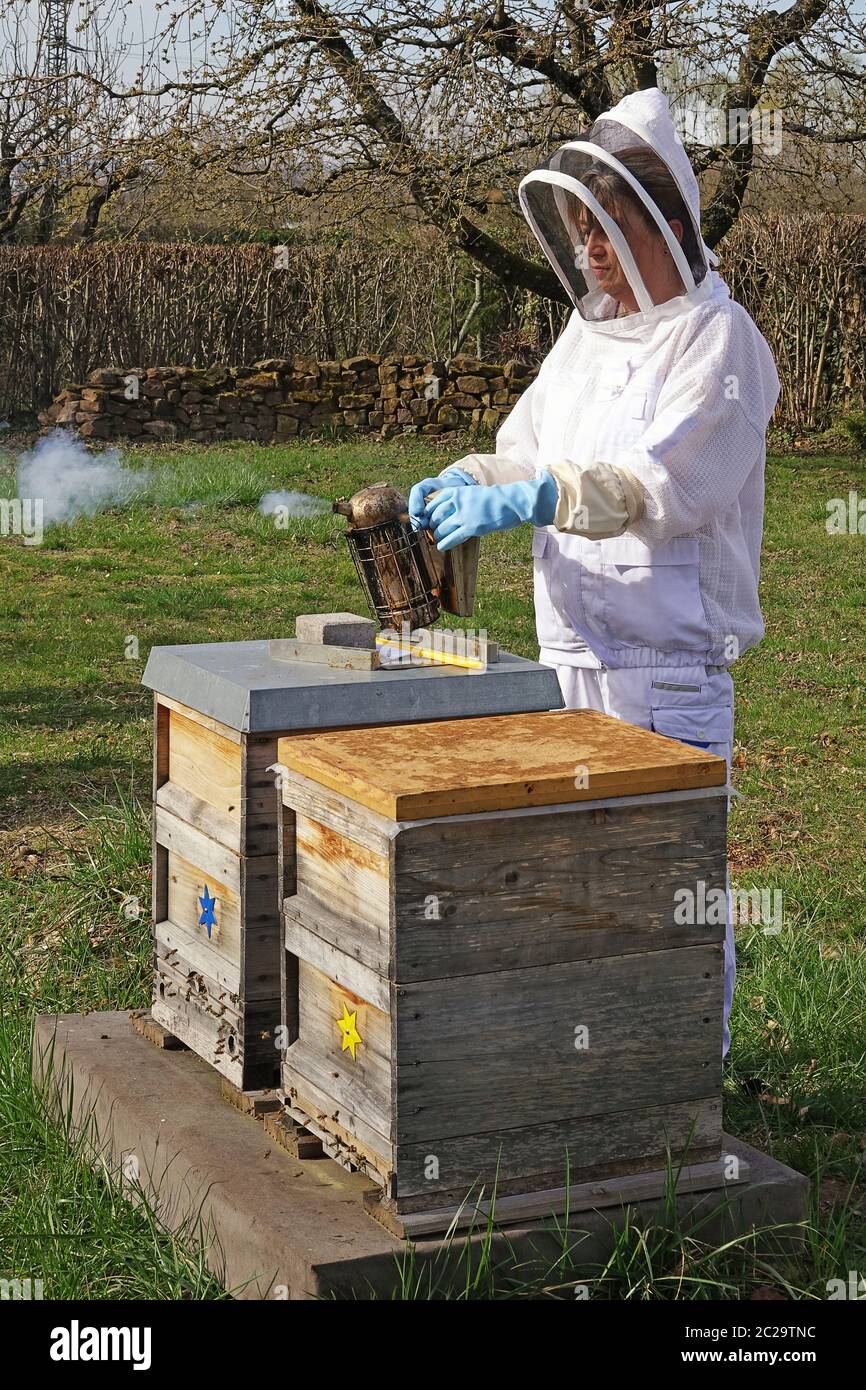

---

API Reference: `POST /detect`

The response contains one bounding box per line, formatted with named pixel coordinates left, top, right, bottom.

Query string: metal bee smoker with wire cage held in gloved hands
left=334, top=482, right=480, bottom=632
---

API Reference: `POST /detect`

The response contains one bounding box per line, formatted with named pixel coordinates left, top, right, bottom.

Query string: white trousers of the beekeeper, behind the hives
left=544, top=664, right=737, bottom=1056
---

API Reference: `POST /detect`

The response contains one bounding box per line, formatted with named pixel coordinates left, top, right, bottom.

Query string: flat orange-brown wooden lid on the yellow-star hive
left=278, top=710, right=727, bottom=820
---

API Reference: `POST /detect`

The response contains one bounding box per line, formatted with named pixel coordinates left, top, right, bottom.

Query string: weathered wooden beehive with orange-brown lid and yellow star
left=279, top=712, right=727, bottom=1233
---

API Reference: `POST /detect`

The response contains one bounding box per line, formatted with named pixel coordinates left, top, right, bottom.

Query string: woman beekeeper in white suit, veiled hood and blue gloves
left=410, top=88, right=780, bottom=1052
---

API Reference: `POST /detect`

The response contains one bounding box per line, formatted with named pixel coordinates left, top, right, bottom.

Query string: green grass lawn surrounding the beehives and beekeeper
left=0, top=436, right=866, bottom=1298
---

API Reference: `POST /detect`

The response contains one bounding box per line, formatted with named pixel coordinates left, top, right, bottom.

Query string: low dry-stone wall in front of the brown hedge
left=39, top=356, right=537, bottom=443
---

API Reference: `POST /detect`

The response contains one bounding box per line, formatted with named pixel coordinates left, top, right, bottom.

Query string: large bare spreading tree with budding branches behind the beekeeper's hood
left=108, top=0, right=866, bottom=299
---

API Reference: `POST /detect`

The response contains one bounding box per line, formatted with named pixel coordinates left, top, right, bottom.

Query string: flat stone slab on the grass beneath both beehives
left=33, top=1012, right=809, bottom=1298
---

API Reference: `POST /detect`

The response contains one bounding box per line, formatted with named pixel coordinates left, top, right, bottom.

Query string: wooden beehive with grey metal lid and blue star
left=143, top=641, right=562, bottom=1090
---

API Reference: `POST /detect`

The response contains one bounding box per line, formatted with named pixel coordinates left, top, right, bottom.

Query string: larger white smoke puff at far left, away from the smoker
left=15, top=430, right=147, bottom=525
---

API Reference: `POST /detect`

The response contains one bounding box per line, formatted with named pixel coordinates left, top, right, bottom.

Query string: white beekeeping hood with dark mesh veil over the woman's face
left=518, top=101, right=716, bottom=320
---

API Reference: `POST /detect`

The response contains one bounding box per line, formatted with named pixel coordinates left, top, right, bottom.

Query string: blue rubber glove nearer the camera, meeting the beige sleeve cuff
left=428, top=473, right=559, bottom=550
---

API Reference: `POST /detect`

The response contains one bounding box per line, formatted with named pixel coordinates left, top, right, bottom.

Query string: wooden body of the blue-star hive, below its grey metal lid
left=152, top=695, right=279, bottom=1090
